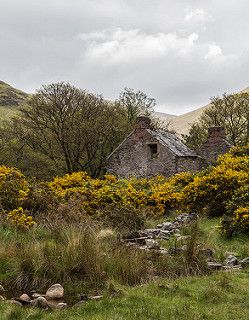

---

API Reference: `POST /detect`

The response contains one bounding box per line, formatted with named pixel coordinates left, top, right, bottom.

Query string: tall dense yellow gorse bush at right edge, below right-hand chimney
left=181, top=148, right=249, bottom=216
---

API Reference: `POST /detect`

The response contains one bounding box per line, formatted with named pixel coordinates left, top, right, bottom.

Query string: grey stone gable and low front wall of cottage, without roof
left=107, top=130, right=200, bottom=178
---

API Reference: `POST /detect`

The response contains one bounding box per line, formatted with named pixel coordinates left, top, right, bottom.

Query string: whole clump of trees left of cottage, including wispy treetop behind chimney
left=0, top=82, right=157, bottom=179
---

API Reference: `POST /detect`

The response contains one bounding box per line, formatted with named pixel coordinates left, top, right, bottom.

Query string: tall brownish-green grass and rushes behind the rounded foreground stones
left=0, top=221, right=209, bottom=292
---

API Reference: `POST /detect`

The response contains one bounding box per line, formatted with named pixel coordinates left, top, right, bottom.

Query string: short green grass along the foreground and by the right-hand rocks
left=0, top=219, right=249, bottom=320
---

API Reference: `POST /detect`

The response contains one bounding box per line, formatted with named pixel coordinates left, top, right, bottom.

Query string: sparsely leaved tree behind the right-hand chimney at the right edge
left=183, top=93, right=249, bottom=149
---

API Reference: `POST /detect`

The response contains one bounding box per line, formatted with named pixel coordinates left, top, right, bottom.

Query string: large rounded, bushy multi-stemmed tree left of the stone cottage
left=0, top=83, right=130, bottom=176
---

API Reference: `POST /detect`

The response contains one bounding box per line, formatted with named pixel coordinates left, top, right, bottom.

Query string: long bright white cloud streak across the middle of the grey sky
left=79, top=28, right=233, bottom=67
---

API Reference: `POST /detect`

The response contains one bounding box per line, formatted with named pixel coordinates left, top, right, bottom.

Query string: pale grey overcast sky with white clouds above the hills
left=0, top=0, right=249, bottom=114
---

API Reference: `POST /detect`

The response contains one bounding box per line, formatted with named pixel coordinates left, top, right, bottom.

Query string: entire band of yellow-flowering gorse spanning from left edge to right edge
left=0, top=146, right=249, bottom=235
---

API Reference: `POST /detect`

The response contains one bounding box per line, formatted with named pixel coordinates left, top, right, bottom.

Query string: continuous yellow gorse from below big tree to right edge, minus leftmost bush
left=49, top=147, right=249, bottom=222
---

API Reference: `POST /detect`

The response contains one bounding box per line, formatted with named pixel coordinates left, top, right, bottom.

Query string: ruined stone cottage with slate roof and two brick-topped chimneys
left=107, top=116, right=233, bottom=178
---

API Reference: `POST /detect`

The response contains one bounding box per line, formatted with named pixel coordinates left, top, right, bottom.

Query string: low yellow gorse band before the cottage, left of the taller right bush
left=48, top=172, right=193, bottom=216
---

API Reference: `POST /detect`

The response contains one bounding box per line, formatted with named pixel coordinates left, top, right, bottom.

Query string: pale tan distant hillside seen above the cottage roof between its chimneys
left=170, top=87, right=249, bottom=135
